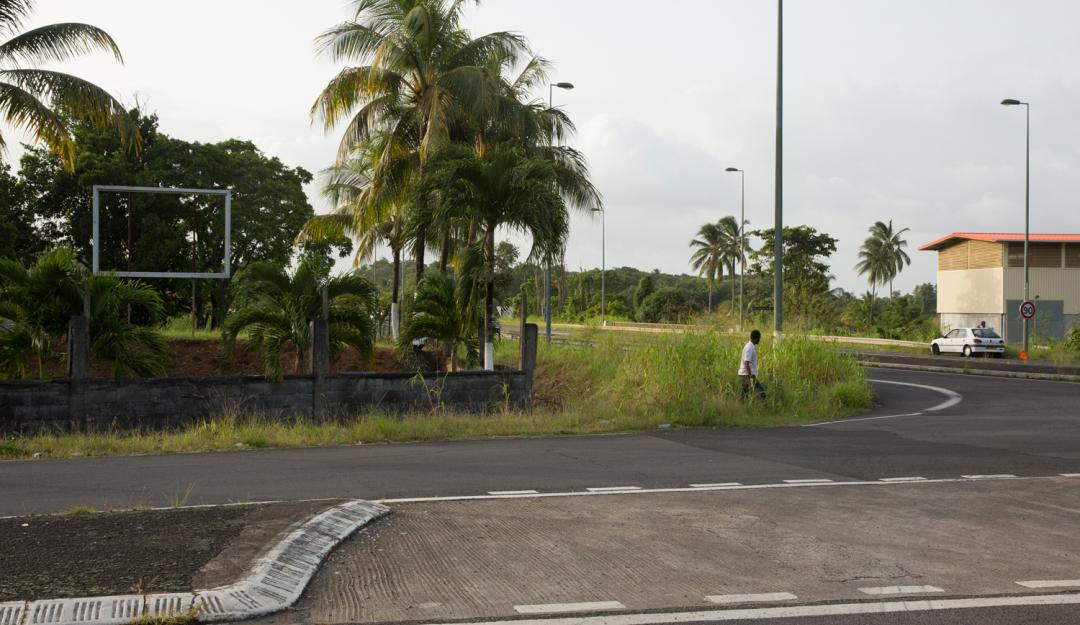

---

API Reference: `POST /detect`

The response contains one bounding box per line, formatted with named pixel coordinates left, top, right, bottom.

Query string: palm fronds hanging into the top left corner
left=0, top=0, right=141, bottom=172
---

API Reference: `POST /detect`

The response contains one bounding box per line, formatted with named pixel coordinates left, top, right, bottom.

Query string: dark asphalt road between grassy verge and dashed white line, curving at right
left=0, top=369, right=1080, bottom=516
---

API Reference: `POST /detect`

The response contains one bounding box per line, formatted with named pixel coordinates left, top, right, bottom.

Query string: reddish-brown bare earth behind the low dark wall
left=39, top=339, right=441, bottom=379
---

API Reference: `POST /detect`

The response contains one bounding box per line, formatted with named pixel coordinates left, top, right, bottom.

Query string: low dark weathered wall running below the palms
left=0, top=371, right=531, bottom=434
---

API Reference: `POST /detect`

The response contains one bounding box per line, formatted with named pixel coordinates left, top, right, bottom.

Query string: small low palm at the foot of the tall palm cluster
left=400, top=271, right=480, bottom=371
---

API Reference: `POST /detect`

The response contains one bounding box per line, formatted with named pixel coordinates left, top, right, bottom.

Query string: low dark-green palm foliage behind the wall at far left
left=0, top=247, right=165, bottom=379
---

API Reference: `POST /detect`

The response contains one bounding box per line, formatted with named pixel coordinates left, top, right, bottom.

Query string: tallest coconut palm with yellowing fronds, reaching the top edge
left=311, top=0, right=526, bottom=284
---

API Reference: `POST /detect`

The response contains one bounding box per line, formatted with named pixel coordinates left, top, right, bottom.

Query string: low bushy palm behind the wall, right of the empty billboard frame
left=224, top=255, right=377, bottom=379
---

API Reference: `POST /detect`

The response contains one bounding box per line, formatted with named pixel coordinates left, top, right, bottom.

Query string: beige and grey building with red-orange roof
left=919, top=232, right=1080, bottom=343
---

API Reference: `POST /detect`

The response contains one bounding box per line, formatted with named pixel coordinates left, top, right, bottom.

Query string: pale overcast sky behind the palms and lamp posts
left=4, top=0, right=1080, bottom=293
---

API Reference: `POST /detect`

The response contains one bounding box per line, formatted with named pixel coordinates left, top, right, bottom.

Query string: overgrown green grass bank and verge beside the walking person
left=0, top=332, right=872, bottom=459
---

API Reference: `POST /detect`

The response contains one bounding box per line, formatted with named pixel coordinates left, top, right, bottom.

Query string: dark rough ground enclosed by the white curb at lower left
left=0, top=502, right=333, bottom=601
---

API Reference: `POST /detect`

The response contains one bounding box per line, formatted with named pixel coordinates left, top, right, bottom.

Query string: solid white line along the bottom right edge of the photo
left=423, top=593, right=1080, bottom=625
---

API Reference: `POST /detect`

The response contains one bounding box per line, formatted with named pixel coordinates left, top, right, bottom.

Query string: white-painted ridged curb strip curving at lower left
left=0, top=500, right=390, bottom=625
